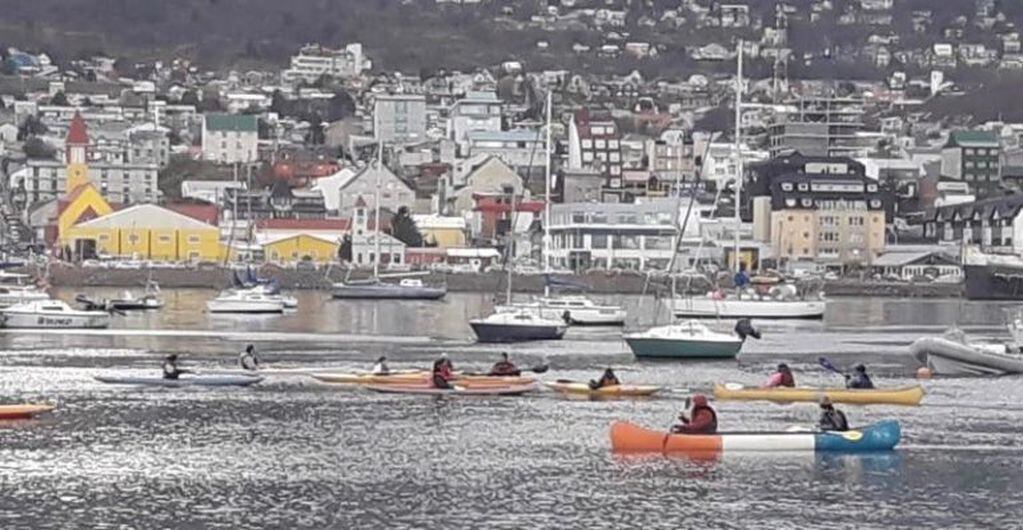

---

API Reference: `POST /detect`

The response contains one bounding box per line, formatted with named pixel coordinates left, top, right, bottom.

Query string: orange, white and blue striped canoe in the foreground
left=611, top=419, right=902, bottom=454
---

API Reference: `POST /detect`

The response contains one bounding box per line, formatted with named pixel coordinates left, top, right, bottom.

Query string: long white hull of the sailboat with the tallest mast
left=674, top=298, right=827, bottom=319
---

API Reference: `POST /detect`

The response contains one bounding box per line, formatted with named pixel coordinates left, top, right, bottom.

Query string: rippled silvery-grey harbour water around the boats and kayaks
left=0, top=291, right=1023, bottom=529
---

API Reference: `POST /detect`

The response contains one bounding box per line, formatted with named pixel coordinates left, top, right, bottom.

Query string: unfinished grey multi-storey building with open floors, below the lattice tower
left=770, top=97, right=863, bottom=157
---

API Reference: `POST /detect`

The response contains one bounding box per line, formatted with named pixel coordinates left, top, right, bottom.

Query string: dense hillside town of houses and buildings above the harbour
left=0, top=0, right=1023, bottom=290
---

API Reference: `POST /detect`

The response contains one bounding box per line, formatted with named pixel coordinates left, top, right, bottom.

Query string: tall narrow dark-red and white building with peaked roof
left=568, top=108, right=622, bottom=181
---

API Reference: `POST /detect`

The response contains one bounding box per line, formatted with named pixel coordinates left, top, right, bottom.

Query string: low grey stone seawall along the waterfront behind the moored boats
left=36, top=265, right=963, bottom=298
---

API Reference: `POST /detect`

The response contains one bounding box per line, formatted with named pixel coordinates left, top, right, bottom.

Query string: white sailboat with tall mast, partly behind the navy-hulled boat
left=494, top=91, right=627, bottom=325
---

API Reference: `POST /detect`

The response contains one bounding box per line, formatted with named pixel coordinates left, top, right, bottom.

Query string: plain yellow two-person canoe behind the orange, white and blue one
left=714, top=383, right=924, bottom=406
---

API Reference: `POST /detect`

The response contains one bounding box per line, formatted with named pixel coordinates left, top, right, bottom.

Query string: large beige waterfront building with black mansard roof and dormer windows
left=753, top=164, right=892, bottom=267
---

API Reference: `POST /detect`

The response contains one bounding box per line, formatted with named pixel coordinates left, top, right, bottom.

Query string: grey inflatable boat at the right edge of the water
left=909, top=337, right=1023, bottom=376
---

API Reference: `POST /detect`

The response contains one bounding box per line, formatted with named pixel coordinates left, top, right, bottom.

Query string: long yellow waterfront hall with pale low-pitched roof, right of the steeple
left=61, top=205, right=223, bottom=262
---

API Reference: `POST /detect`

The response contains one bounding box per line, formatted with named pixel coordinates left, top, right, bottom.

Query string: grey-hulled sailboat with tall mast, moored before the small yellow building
left=331, top=143, right=447, bottom=300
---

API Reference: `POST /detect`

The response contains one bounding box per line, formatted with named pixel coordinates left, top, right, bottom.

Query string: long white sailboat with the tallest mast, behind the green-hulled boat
left=673, top=40, right=827, bottom=319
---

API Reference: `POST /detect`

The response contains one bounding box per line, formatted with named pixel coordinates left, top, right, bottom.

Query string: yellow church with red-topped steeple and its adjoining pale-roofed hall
left=52, top=113, right=223, bottom=262
